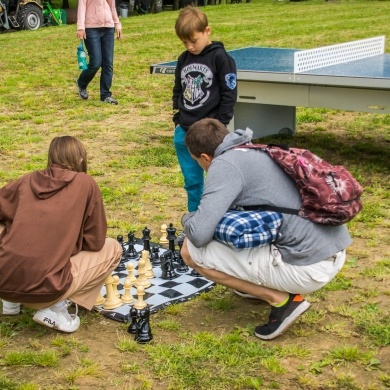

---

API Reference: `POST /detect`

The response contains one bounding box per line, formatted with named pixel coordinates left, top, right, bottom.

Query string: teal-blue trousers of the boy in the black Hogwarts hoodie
left=173, top=125, right=204, bottom=212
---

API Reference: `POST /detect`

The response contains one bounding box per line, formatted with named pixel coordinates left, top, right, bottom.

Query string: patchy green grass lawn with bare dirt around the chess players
left=0, top=0, right=390, bottom=390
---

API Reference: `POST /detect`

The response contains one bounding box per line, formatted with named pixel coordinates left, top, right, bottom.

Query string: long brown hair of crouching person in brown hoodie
left=47, top=135, right=87, bottom=173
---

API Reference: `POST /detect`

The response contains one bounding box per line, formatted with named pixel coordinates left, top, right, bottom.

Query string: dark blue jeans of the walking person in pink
left=77, top=27, right=115, bottom=100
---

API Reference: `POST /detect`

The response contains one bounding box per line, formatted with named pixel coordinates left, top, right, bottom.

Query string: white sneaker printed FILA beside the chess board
left=33, top=302, right=80, bottom=333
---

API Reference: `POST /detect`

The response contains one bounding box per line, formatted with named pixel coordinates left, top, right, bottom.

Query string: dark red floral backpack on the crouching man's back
left=237, top=144, right=363, bottom=225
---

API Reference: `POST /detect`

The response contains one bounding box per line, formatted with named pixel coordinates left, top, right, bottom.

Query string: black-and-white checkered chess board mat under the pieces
left=95, top=239, right=215, bottom=323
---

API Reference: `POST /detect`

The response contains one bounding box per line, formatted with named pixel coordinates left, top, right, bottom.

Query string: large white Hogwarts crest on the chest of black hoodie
left=181, top=64, right=213, bottom=110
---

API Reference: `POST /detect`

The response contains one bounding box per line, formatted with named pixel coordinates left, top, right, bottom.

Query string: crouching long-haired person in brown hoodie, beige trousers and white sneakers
left=0, top=136, right=122, bottom=333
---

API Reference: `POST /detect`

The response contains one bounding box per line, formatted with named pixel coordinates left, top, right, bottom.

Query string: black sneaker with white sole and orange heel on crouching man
left=255, top=294, right=310, bottom=340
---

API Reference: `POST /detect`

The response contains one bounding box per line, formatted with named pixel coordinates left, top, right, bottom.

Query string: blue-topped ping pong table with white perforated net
left=150, top=37, right=390, bottom=138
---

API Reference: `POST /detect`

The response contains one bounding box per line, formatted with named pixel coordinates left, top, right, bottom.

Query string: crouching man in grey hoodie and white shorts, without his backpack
left=181, top=119, right=352, bottom=340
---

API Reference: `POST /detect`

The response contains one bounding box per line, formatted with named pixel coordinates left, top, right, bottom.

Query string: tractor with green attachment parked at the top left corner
left=0, top=0, right=62, bottom=30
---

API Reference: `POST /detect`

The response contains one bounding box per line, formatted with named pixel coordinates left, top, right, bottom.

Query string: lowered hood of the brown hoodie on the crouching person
left=30, top=165, right=78, bottom=199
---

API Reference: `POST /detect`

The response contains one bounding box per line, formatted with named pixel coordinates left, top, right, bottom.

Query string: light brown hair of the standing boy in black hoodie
left=175, top=6, right=209, bottom=40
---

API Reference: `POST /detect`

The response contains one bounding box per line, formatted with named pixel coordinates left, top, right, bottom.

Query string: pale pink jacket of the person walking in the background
left=77, top=0, right=122, bottom=30
